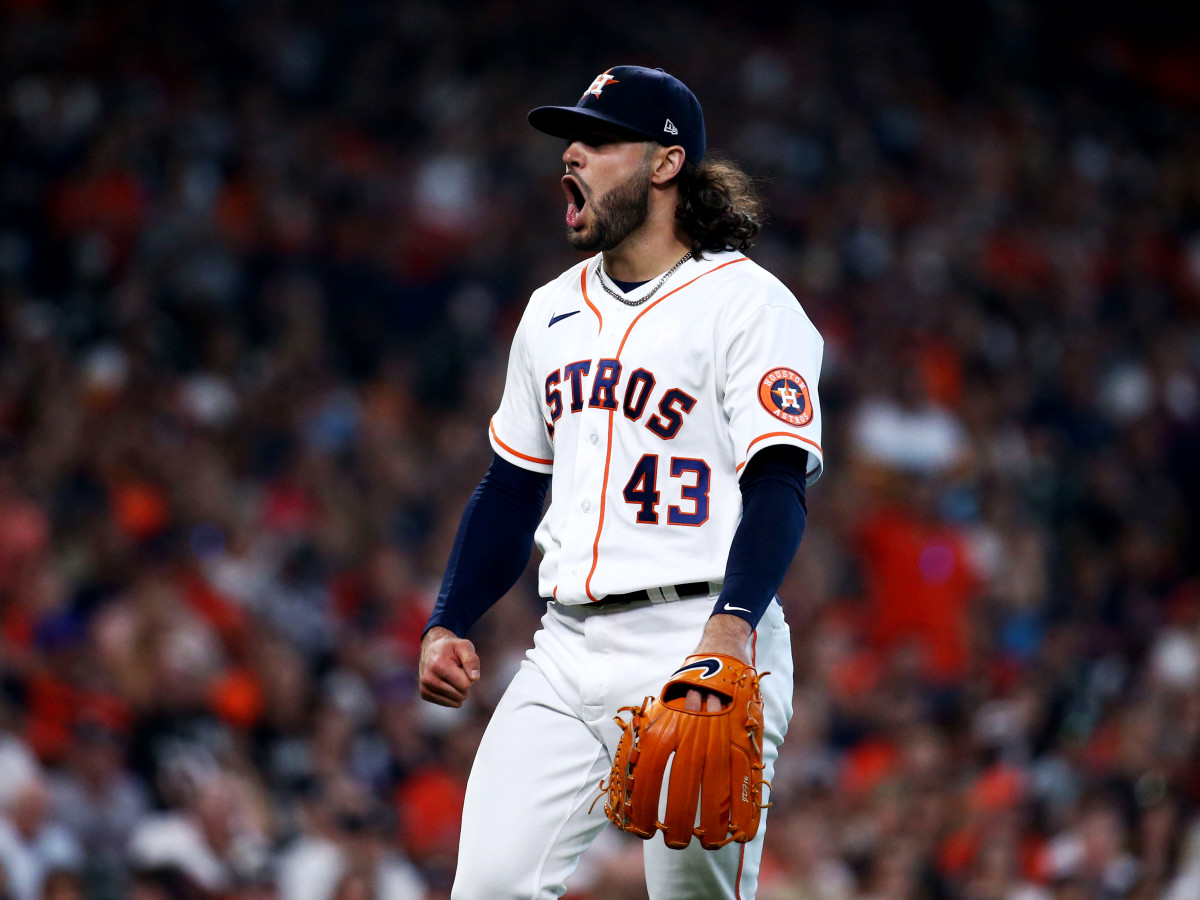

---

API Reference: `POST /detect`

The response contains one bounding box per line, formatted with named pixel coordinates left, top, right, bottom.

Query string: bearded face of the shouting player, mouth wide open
left=562, top=131, right=654, bottom=252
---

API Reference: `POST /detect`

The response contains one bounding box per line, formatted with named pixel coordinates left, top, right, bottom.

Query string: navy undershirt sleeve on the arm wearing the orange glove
left=713, top=445, right=808, bottom=628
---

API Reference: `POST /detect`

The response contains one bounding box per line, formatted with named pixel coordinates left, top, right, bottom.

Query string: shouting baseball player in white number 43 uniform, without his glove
left=419, top=66, right=823, bottom=900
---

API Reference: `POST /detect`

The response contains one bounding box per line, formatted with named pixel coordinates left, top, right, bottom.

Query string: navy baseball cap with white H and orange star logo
left=529, top=66, right=706, bottom=162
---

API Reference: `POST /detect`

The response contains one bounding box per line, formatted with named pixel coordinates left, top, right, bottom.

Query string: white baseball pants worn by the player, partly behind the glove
left=451, top=596, right=792, bottom=900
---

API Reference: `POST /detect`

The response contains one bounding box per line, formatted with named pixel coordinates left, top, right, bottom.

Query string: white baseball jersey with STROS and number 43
left=491, top=252, right=823, bottom=604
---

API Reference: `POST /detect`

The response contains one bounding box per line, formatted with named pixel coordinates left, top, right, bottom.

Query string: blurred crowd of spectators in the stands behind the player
left=0, top=0, right=1200, bottom=900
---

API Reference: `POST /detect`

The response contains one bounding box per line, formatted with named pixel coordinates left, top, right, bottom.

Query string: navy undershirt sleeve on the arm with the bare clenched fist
left=425, top=456, right=550, bottom=637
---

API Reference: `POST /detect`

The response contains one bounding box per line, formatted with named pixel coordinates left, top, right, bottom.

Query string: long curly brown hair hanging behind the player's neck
left=676, top=156, right=762, bottom=258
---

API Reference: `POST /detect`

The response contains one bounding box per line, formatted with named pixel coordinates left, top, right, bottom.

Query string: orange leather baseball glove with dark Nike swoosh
left=600, top=655, right=770, bottom=850
